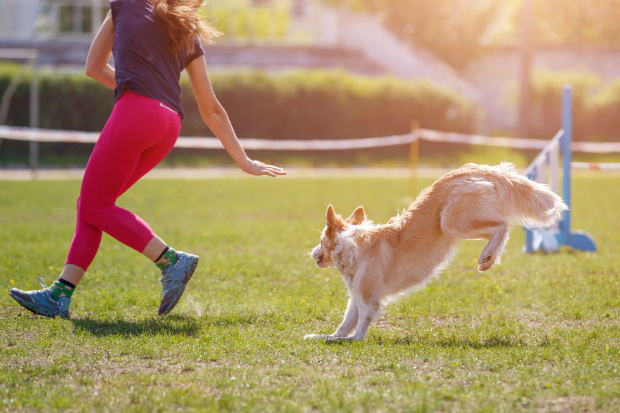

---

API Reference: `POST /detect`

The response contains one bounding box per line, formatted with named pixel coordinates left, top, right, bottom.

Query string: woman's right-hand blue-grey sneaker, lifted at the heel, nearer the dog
left=157, top=251, right=198, bottom=315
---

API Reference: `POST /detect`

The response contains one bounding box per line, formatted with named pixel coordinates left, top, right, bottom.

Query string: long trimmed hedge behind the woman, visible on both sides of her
left=0, top=66, right=475, bottom=139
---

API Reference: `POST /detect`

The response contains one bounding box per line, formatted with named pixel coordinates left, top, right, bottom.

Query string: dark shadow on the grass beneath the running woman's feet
left=71, top=315, right=201, bottom=337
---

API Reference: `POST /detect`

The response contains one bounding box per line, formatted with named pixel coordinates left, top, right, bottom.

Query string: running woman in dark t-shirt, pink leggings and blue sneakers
left=9, top=0, right=286, bottom=318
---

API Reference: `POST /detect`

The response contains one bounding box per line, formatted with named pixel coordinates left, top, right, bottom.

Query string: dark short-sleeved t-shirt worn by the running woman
left=110, top=0, right=204, bottom=120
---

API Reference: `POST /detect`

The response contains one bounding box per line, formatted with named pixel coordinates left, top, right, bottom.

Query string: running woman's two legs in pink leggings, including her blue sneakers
left=9, top=92, right=186, bottom=318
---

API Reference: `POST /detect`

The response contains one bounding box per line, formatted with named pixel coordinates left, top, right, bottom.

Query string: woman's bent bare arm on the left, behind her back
left=86, top=12, right=116, bottom=89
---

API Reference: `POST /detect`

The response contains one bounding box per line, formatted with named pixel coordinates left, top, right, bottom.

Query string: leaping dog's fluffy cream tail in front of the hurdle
left=496, top=163, right=568, bottom=229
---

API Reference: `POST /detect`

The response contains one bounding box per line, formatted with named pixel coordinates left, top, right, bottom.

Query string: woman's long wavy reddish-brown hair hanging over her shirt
left=151, top=0, right=220, bottom=54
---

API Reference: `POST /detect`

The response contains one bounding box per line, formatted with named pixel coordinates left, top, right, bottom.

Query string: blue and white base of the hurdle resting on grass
left=523, top=229, right=596, bottom=253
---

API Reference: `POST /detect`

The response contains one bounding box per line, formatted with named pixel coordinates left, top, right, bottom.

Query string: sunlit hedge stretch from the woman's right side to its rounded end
left=182, top=71, right=476, bottom=139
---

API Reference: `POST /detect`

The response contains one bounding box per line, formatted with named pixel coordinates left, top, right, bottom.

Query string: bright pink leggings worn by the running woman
left=66, top=90, right=181, bottom=270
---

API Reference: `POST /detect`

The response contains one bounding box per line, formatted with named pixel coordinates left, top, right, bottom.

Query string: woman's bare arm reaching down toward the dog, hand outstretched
left=185, top=56, right=286, bottom=177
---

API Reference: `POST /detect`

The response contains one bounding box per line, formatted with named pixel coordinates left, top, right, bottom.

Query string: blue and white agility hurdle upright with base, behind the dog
left=523, top=85, right=596, bottom=252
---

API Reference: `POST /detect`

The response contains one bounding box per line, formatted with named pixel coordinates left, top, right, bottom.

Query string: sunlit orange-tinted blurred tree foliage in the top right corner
left=324, top=0, right=620, bottom=69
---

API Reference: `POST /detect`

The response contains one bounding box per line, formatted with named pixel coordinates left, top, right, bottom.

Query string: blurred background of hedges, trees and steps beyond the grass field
left=0, top=0, right=620, bottom=168
